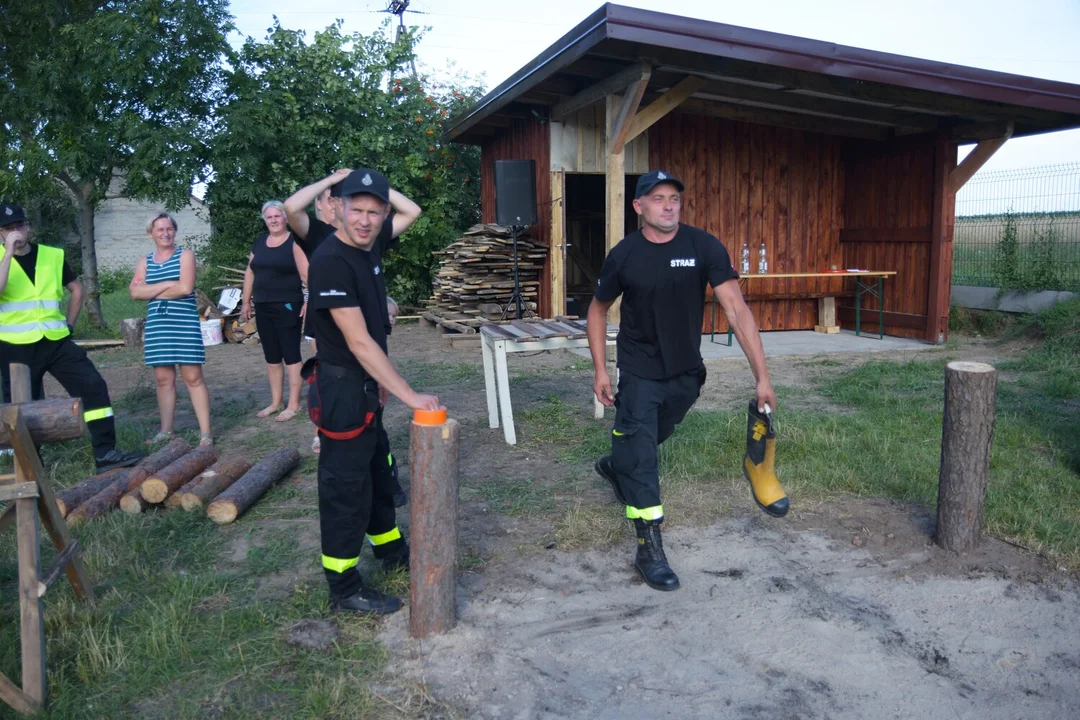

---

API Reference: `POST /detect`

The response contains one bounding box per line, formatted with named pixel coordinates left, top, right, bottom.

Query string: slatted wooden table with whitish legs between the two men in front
left=480, top=317, right=619, bottom=445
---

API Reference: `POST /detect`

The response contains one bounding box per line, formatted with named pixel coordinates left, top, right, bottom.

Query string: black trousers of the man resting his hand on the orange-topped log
left=317, top=365, right=405, bottom=597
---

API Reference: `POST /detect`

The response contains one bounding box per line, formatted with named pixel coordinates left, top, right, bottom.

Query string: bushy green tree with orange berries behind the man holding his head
left=204, top=23, right=480, bottom=302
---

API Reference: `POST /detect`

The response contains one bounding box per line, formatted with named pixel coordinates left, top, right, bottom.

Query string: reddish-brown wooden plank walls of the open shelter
left=482, top=110, right=956, bottom=340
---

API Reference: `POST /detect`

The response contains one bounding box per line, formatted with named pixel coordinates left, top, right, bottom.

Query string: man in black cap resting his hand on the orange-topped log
left=308, top=169, right=440, bottom=613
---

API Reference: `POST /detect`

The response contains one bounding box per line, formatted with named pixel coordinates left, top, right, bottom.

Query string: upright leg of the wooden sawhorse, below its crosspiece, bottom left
left=15, top=498, right=48, bottom=707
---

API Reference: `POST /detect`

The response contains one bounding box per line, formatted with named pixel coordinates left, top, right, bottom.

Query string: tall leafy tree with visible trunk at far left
left=0, top=0, right=232, bottom=324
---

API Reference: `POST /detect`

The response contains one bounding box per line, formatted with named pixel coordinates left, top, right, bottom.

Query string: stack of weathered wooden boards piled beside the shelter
left=428, top=225, right=548, bottom=327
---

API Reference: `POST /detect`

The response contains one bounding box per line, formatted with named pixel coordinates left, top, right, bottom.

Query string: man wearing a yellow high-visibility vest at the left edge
left=0, top=204, right=143, bottom=472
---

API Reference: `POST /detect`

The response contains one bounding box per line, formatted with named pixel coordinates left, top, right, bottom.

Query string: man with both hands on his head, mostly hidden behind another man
left=285, top=169, right=421, bottom=507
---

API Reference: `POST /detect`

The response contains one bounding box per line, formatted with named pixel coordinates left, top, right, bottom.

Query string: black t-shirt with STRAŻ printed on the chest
left=596, top=225, right=739, bottom=380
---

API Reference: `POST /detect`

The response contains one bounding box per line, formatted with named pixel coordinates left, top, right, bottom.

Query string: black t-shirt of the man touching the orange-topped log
left=308, top=237, right=387, bottom=367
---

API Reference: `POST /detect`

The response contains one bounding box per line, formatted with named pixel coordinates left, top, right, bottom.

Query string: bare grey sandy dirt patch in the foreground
left=381, top=506, right=1080, bottom=719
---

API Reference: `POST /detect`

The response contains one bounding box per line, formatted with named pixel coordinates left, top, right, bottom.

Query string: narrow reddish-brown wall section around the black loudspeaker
left=481, top=119, right=553, bottom=317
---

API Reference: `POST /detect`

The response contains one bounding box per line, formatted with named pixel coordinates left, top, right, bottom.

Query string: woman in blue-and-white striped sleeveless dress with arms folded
left=129, top=213, right=214, bottom=446
